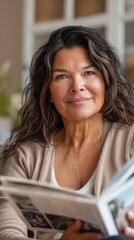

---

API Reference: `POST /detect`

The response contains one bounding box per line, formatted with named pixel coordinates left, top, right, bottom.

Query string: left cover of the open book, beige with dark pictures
left=0, top=176, right=118, bottom=234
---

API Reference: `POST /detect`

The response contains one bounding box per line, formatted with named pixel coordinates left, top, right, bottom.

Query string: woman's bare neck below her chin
left=63, top=114, right=103, bottom=150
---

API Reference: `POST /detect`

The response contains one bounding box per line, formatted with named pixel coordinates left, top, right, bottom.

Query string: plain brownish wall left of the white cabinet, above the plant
left=0, top=0, right=23, bottom=91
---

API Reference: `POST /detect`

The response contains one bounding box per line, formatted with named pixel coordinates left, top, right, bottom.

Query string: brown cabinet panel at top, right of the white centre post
left=75, top=0, right=105, bottom=17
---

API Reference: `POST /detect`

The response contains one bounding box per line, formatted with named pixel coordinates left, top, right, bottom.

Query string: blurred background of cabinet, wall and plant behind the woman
left=0, top=0, right=134, bottom=144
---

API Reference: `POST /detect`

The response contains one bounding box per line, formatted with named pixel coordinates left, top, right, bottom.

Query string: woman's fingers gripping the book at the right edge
left=123, top=211, right=134, bottom=237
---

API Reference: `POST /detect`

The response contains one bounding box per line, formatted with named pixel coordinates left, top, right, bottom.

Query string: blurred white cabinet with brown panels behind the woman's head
left=23, top=0, right=134, bottom=82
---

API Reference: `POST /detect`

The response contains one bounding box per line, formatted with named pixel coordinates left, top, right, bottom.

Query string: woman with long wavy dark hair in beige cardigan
left=0, top=26, right=134, bottom=240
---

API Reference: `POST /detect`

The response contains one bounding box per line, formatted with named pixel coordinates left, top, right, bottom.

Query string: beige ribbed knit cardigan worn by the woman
left=0, top=122, right=134, bottom=240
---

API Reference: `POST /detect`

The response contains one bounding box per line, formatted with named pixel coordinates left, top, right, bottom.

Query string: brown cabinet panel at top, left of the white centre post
left=35, top=0, right=63, bottom=22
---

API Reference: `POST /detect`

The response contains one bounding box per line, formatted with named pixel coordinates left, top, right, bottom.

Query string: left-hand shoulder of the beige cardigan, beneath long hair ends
left=4, top=141, right=53, bottom=179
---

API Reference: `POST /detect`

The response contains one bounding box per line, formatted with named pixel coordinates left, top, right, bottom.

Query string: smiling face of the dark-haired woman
left=50, top=47, right=105, bottom=121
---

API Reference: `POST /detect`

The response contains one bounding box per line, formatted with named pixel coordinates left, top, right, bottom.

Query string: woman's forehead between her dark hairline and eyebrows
left=52, top=47, right=91, bottom=68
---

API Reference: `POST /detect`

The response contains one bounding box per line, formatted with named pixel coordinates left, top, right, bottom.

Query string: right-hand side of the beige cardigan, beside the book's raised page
left=96, top=122, right=134, bottom=194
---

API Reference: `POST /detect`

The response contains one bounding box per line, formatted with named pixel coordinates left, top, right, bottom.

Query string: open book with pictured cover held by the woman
left=0, top=158, right=134, bottom=235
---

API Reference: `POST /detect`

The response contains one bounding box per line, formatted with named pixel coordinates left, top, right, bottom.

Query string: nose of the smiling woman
left=71, top=77, right=85, bottom=93
